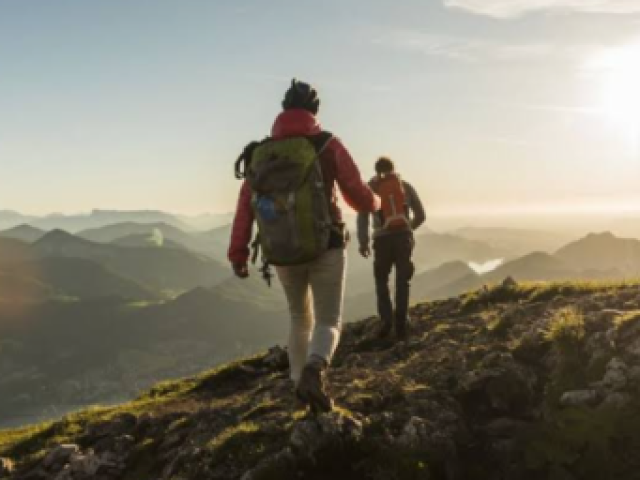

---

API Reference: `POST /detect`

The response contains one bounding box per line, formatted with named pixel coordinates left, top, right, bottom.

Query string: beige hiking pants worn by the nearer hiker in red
left=276, top=248, right=347, bottom=382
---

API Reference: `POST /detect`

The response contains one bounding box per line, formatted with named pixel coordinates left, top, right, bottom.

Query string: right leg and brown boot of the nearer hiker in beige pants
left=297, top=249, right=346, bottom=412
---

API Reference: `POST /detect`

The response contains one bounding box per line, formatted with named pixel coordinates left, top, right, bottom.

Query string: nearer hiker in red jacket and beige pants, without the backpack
left=228, top=80, right=379, bottom=411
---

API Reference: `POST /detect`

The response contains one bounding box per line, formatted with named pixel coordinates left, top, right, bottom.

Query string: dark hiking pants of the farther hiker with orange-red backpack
left=373, top=232, right=414, bottom=332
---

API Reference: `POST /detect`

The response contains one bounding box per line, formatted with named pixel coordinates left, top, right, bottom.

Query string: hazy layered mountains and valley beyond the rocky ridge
left=0, top=210, right=640, bottom=424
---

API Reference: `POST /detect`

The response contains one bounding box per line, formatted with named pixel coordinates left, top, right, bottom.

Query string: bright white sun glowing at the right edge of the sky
left=591, top=43, right=640, bottom=148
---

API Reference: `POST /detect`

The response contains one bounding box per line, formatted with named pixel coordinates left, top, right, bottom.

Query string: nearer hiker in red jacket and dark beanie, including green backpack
left=228, top=79, right=379, bottom=411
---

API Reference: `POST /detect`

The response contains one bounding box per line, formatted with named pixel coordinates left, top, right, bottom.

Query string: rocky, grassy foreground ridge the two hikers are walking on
left=0, top=280, right=640, bottom=480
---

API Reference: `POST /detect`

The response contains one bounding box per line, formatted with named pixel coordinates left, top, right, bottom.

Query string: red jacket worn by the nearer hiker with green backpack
left=228, top=109, right=380, bottom=264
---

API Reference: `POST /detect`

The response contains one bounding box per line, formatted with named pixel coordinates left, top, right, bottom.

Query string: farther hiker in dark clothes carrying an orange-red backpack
left=358, top=157, right=425, bottom=340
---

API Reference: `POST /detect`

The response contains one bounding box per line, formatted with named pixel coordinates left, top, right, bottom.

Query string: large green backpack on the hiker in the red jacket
left=246, top=133, right=334, bottom=266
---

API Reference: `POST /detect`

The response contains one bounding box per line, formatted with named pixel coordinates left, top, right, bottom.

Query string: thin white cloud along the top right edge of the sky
left=444, top=0, right=640, bottom=19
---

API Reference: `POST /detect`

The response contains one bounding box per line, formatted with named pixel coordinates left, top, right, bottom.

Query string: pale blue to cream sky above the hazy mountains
left=0, top=0, right=640, bottom=215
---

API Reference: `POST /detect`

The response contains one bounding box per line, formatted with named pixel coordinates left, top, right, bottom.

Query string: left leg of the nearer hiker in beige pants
left=276, top=265, right=313, bottom=383
